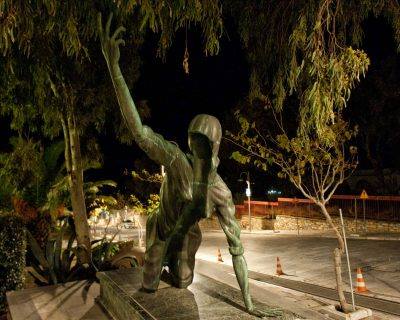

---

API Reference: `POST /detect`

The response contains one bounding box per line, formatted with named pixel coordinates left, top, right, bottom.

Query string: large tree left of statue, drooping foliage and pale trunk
left=0, top=0, right=222, bottom=265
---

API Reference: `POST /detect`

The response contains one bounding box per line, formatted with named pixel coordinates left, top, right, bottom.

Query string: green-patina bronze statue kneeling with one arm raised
left=98, top=15, right=281, bottom=317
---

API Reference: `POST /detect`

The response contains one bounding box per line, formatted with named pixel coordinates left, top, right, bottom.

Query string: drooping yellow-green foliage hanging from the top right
left=224, top=0, right=400, bottom=135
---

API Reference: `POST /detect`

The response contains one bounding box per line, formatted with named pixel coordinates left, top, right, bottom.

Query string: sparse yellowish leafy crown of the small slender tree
left=230, top=113, right=357, bottom=203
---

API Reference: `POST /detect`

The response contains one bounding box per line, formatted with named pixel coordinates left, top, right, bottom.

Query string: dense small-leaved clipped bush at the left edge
left=0, top=214, right=26, bottom=314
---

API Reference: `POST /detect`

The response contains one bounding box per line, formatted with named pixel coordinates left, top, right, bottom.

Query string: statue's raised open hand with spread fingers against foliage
left=97, top=13, right=126, bottom=68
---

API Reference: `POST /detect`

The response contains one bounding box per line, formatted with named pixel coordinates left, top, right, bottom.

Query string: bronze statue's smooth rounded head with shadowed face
left=188, top=114, right=222, bottom=160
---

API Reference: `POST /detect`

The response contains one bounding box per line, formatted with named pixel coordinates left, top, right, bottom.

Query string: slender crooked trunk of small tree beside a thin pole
left=317, top=203, right=353, bottom=313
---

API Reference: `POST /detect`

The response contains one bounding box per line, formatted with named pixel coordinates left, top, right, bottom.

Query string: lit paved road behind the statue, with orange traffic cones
left=196, top=232, right=400, bottom=301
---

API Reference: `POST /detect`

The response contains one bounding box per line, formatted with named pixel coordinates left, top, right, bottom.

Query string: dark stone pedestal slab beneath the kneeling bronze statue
left=97, top=269, right=282, bottom=320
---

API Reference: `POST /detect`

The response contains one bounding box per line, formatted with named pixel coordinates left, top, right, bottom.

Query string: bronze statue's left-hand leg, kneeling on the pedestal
left=142, top=214, right=165, bottom=292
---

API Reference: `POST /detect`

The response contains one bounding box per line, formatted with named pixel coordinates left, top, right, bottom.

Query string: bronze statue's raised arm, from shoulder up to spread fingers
left=97, top=13, right=182, bottom=167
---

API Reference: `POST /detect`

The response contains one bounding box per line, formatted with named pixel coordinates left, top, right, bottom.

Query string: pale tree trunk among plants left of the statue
left=62, top=115, right=91, bottom=266
